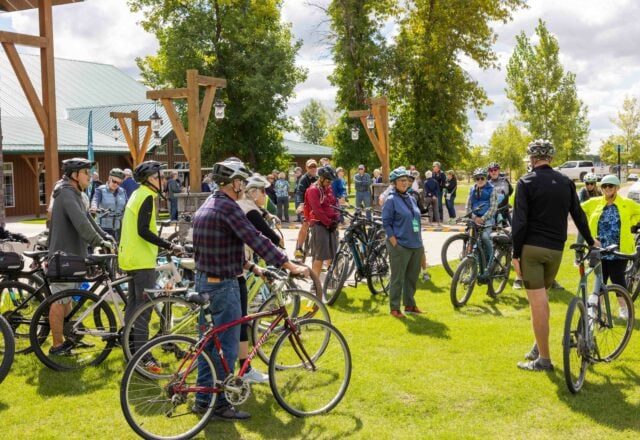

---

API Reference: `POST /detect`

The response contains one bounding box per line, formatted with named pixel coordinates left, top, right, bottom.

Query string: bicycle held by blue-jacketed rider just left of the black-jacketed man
left=450, top=216, right=512, bottom=308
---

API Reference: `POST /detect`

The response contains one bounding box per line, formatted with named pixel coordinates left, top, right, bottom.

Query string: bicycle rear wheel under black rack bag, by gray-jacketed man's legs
left=29, top=289, right=118, bottom=371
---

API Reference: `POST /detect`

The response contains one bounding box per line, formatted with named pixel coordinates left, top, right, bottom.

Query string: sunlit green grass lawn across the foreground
left=0, top=237, right=640, bottom=439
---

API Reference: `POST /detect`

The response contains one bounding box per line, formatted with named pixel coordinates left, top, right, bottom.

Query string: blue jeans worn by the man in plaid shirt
left=196, top=272, right=242, bottom=406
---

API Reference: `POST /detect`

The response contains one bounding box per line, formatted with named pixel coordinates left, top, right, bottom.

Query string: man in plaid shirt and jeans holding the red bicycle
left=193, top=159, right=305, bottom=420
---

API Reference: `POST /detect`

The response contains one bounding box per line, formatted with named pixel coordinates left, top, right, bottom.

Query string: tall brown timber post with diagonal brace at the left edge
left=0, top=0, right=84, bottom=206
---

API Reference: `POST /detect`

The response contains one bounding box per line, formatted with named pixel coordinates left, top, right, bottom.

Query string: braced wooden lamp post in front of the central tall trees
left=348, top=96, right=390, bottom=182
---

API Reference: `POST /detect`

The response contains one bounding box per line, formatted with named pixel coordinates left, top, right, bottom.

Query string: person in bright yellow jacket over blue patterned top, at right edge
left=581, top=174, right=640, bottom=319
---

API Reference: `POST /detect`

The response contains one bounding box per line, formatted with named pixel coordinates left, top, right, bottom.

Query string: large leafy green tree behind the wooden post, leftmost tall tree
left=129, top=0, right=306, bottom=171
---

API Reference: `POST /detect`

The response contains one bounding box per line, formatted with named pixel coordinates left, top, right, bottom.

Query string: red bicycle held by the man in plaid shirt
left=120, top=272, right=352, bottom=439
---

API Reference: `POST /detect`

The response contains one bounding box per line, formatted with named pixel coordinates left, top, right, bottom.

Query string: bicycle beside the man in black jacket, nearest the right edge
left=562, top=243, right=640, bottom=394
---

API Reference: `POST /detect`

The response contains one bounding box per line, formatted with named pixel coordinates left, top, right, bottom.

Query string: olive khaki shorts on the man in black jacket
left=520, top=244, right=562, bottom=290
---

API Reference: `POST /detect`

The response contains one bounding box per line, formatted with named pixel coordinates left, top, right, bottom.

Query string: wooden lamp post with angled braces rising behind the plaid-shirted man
left=147, top=69, right=227, bottom=192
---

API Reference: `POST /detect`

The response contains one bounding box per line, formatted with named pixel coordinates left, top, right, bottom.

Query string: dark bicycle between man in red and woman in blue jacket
left=322, top=206, right=390, bottom=305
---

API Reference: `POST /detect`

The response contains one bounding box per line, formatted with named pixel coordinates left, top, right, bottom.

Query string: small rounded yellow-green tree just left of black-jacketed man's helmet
left=489, top=119, right=532, bottom=178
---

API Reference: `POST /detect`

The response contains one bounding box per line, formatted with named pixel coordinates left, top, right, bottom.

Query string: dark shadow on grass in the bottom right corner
left=554, top=367, right=640, bottom=431
